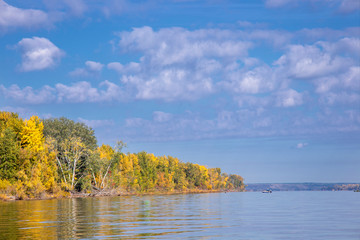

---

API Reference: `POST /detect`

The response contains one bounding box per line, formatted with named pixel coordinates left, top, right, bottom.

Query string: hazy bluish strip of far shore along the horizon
left=246, top=183, right=360, bottom=192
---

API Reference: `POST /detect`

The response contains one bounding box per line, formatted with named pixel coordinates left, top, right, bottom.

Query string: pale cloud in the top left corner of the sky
left=0, top=0, right=51, bottom=29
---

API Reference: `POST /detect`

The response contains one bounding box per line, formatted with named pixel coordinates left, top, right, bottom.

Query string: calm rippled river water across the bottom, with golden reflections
left=0, top=191, right=360, bottom=240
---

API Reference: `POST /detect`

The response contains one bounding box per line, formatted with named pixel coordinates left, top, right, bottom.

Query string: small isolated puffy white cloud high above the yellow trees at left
left=17, top=37, right=65, bottom=72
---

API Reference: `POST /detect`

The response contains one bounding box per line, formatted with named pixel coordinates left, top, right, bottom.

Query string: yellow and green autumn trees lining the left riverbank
left=0, top=112, right=244, bottom=199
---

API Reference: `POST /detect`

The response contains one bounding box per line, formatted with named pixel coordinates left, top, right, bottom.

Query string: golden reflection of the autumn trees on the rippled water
left=0, top=194, right=219, bottom=239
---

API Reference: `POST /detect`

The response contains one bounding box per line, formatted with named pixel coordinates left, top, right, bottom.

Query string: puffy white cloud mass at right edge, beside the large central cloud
left=274, top=37, right=360, bottom=105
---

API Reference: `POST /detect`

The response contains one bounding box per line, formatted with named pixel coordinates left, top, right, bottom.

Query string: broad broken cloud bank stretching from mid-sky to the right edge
left=107, top=27, right=359, bottom=107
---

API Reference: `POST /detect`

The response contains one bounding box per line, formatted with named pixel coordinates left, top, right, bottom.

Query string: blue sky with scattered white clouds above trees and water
left=0, top=0, right=360, bottom=183
